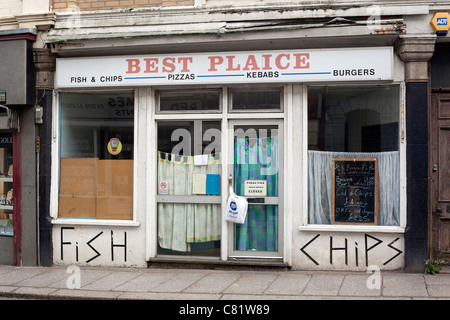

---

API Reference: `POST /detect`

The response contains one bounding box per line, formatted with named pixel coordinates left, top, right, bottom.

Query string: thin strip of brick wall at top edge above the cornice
left=53, top=0, right=194, bottom=12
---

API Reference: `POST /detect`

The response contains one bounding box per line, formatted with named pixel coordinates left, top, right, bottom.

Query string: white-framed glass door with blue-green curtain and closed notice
left=228, top=120, right=283, bottom=259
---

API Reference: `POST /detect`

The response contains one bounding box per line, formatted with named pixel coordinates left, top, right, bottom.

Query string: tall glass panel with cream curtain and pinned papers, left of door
left=157, top=119, right=222, bottom=256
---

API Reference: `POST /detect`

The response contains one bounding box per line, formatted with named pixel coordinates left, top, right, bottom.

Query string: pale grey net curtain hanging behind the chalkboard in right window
left=308, top=151, right=400, bottom=226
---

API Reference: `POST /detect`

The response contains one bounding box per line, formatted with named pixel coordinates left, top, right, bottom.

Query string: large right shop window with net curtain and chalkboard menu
left=308, top=85, right=400, bottom=226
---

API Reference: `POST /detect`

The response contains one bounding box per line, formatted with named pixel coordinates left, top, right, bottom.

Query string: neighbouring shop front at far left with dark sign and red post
left=0, top=28, right=39, bottom=266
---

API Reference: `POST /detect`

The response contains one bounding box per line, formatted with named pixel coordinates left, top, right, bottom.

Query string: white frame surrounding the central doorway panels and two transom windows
left=145, top=84, right=292, bottom=263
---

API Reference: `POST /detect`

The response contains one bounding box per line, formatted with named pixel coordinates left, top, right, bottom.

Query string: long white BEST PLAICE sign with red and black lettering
left=55, top=47, right=393, bottom=88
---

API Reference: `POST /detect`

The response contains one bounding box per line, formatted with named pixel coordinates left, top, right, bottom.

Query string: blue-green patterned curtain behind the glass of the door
left=234, top=137, right=278, bottom=251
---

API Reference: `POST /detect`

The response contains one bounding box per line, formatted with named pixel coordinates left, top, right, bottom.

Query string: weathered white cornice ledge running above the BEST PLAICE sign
left=45, top=3, right=429, bottom=57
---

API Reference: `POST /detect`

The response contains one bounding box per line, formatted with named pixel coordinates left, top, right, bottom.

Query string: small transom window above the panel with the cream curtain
left=157, top=90, right=220, bottom=112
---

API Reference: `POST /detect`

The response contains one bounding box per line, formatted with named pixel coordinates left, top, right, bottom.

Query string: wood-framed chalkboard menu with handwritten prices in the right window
left=331, top=158, right=378, bottom=224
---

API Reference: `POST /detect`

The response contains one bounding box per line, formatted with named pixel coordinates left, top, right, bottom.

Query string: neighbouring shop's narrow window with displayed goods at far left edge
left=0, top=132, right=14, bottom=236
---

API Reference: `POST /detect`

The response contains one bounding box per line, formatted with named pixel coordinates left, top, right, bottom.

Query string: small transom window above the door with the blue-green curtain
left=231, top=89, right=282, bottom=111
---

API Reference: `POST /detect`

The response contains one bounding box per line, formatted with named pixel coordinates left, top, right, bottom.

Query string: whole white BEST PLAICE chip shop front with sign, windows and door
left=50, top=46, right=406, bottom=270
